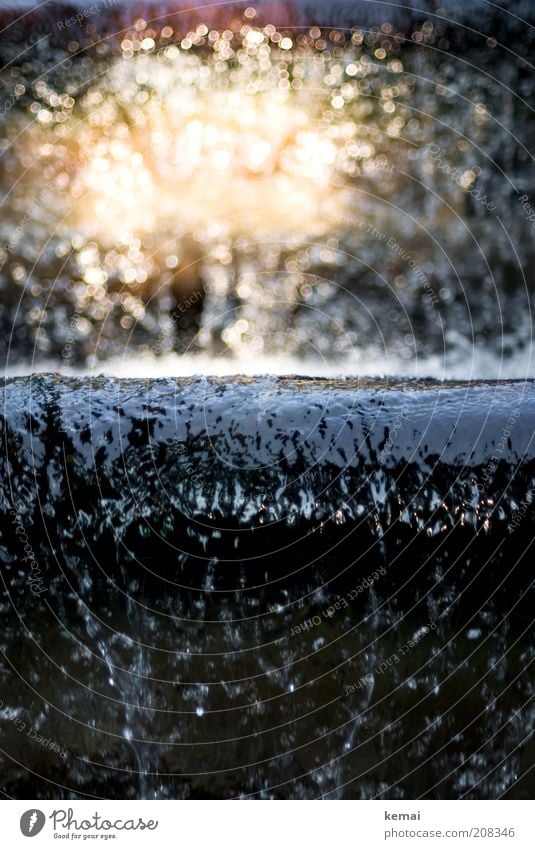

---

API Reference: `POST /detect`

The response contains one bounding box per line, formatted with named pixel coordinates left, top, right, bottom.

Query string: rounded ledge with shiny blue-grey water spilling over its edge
left=0, top=375, right=535, bottom=588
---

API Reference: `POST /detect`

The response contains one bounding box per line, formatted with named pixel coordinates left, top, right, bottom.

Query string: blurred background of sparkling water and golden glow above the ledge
left=0, top=0, right=535, bottom=377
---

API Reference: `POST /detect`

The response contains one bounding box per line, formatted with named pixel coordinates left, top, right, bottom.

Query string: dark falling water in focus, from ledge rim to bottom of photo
left=0, top=376, right=535, bottom=799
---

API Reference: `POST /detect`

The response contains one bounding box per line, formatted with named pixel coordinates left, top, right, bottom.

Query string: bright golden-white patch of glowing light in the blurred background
left=72, top=47, right=350, bottom=241
